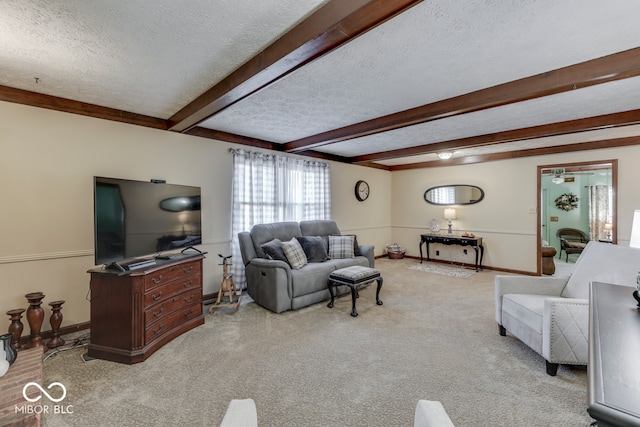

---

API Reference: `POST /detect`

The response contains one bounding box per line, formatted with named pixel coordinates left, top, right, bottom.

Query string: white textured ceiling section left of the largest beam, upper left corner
left=0, top=0, right=326, bottom=119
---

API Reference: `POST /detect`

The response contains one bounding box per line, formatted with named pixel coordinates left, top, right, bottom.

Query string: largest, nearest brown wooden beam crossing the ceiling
left=169, top=0, right=422, bottom=132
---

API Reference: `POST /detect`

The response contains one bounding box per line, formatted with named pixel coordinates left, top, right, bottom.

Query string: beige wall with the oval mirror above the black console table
left=391, top=146, right=640, bottom=272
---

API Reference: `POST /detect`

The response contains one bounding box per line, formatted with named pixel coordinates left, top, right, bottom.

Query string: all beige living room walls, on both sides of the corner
left=0, top=102, right=640, bottom=334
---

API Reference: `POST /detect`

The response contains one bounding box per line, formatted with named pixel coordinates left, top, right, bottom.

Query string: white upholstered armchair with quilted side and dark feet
left=495, top=241, right=640, bottom=376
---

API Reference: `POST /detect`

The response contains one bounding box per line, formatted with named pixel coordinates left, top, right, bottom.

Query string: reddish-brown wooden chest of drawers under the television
left=88, top=254, right=204, bottom=364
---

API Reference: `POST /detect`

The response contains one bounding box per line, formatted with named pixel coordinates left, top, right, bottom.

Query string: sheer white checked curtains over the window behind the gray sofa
left=230, top=149, right=331, bottom=288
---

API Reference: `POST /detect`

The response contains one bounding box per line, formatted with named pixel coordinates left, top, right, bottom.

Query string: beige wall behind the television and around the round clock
left=0, top=102, right=391, bottom=334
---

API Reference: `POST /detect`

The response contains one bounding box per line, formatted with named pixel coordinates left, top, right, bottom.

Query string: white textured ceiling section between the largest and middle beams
left=202, top=0, right=640, bottom=143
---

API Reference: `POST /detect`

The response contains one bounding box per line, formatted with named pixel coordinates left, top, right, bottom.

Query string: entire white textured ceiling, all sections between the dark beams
left=0, top=0, right=640, bottom=167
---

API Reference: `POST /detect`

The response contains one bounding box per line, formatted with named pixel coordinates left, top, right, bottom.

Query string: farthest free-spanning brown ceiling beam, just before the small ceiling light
left=351, top=110, right=640, bottom=163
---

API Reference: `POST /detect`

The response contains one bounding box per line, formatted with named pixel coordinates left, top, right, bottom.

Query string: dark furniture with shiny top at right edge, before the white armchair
left=587, top=282, right=640, bottom=427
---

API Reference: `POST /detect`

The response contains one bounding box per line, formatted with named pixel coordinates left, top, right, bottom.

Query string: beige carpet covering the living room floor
left=38, top=259, right=590, bottom=427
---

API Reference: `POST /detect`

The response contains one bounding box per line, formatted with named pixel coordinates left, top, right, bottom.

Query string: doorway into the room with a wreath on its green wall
left=537, top=160, right=618, bottom=275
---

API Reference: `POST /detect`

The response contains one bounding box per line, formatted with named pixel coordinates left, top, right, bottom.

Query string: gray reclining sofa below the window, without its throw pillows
left=238, top=220, right=374, bottom=313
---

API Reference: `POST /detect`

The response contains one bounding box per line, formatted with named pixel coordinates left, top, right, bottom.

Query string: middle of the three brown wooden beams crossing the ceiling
left=285, top=48, right=640, bottom=152
